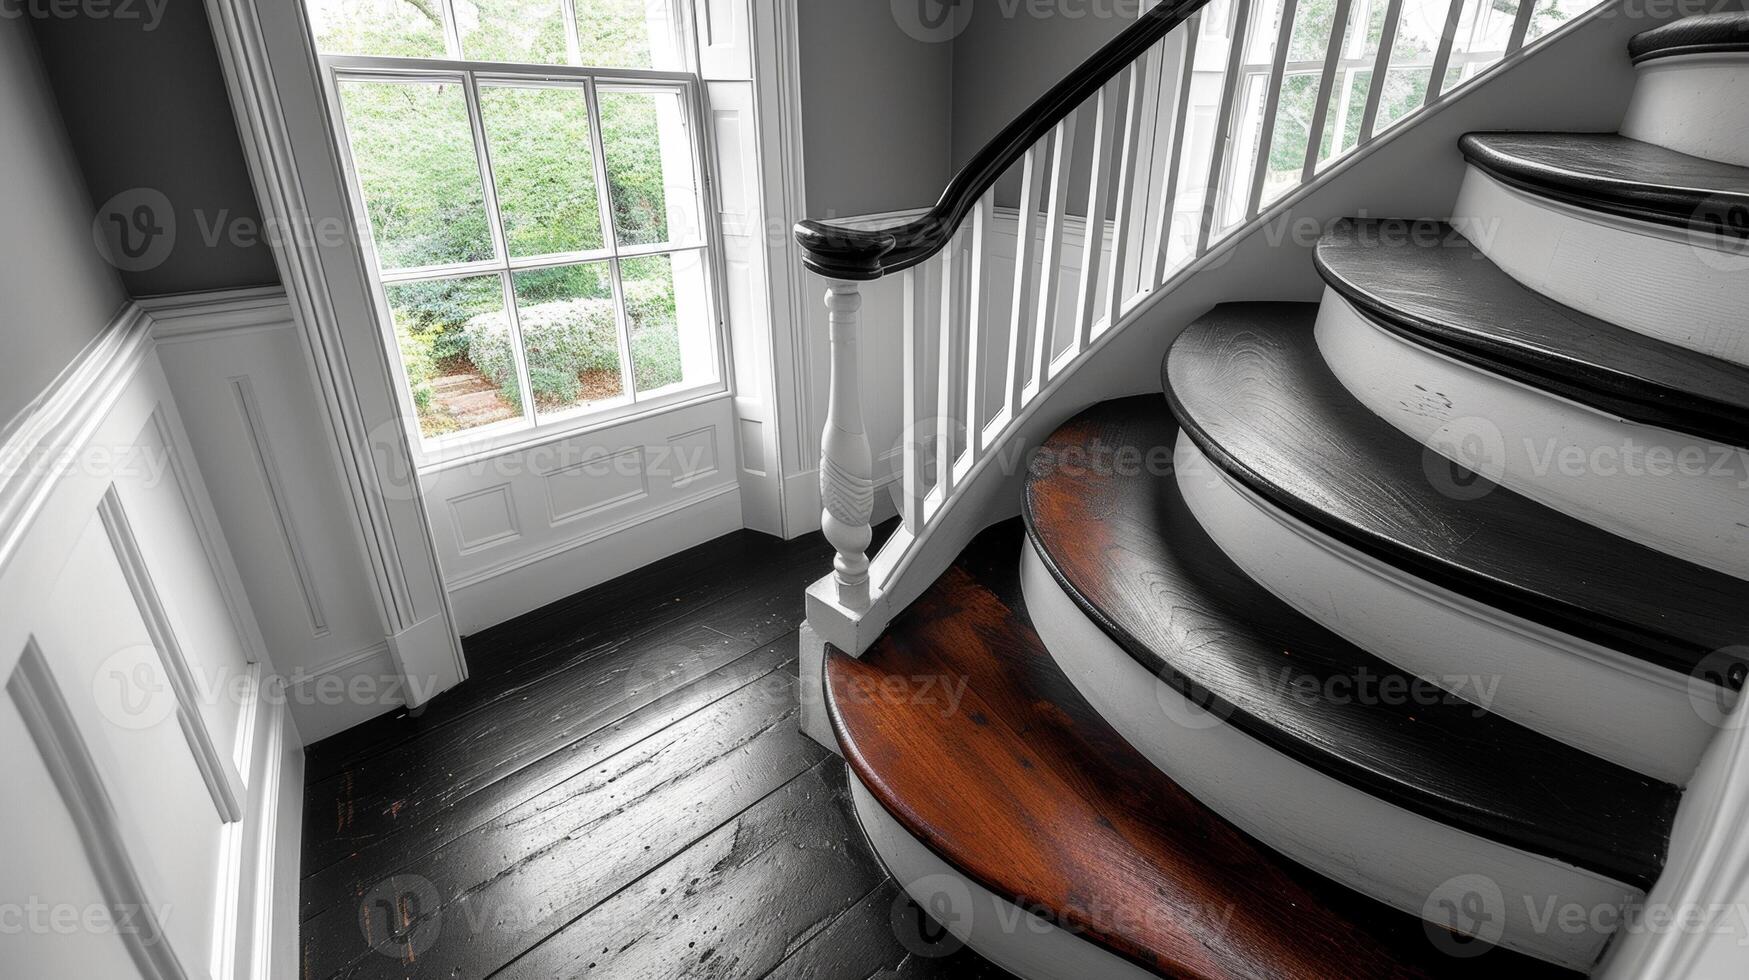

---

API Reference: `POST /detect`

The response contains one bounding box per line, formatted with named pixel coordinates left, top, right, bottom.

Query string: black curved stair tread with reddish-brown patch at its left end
left=1025, top=396, right=1679, bottom=887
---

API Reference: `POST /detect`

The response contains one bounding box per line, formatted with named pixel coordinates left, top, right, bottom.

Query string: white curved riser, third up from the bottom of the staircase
left=1175, top=434, right=1712, bottom=786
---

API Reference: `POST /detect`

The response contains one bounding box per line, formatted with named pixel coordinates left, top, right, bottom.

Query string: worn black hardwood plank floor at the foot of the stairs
left=301, top=532, right=1006, bottom=980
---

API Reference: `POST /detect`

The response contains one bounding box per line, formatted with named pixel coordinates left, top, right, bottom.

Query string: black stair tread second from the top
left=1459, top=133, right=1749, bottom=238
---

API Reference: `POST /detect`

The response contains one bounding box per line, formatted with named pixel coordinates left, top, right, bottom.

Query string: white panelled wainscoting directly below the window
left=420, top=394, right=742, bottom=634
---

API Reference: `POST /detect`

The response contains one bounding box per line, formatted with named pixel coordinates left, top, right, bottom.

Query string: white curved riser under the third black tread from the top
left=1317, top=289, right=1749, bottom=579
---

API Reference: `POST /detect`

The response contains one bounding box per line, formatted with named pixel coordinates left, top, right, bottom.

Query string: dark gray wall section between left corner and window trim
left=33, top=0, right=278, bottom=296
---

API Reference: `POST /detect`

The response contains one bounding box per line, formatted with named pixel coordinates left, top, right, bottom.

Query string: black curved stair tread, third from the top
left=1315, top=219, right=1749, bottom=446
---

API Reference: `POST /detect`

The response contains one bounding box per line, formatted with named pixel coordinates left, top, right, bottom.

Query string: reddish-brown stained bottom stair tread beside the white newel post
left=826, top=522, right=1576, bottom=980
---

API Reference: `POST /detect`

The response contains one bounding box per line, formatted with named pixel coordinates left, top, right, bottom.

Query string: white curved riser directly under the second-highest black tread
left=1452, top=166, right=1749, bottom=364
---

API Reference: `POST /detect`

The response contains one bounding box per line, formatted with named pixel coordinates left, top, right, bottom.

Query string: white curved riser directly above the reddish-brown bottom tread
left=1021, top=544, right=1641, bottom=971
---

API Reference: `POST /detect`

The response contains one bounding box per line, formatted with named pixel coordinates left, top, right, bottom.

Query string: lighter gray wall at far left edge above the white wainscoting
left=0, top=18, right=124, bottom=427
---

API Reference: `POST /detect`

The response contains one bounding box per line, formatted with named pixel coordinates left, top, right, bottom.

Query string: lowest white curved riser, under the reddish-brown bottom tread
left=850, top=770, right=1154, bottom=980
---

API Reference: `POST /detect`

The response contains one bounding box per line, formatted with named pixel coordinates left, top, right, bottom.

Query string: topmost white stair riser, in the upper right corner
left=1621, top=54, right=1749, bottom=166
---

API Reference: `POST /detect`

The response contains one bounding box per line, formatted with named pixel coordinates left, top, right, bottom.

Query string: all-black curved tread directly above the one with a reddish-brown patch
left=1165, top=303, right=1749, bottom=688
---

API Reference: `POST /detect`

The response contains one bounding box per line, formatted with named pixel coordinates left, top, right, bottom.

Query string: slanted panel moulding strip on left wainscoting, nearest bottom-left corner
left=5, top=641, right=191, bottom=980
